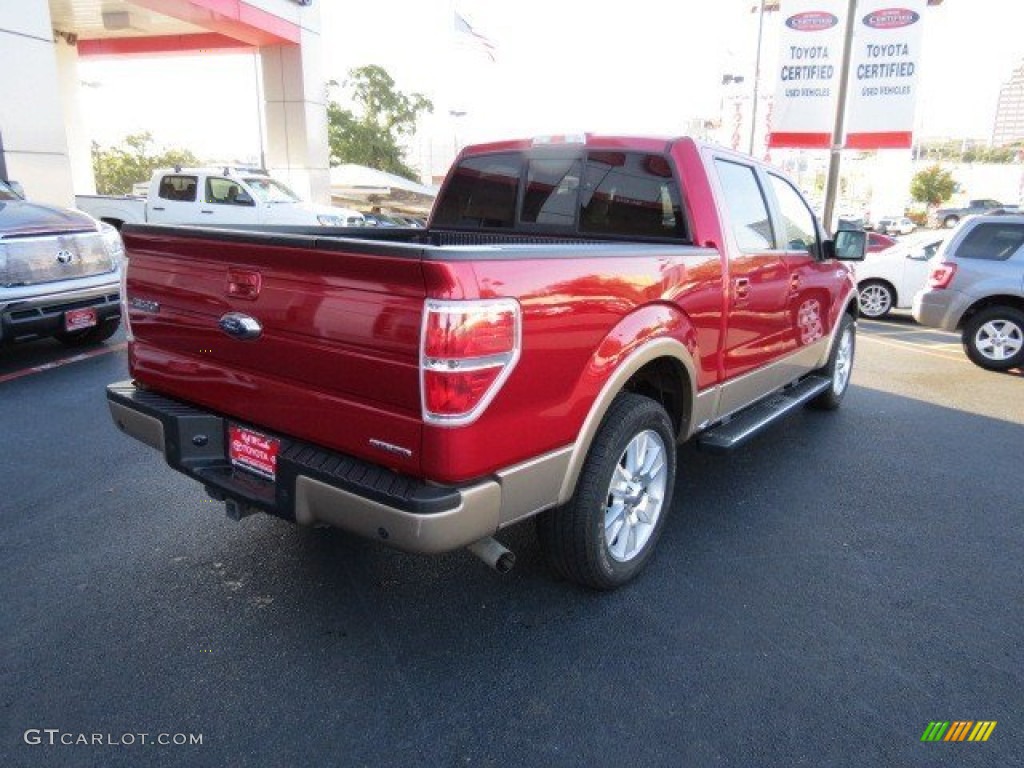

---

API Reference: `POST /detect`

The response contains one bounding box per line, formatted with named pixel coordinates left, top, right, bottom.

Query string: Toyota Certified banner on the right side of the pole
left=845, top=0, right=927, bottom=150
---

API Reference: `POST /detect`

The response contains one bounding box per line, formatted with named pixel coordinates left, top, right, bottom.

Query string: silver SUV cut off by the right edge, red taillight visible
left=913, top=214, right=1024, bottom=371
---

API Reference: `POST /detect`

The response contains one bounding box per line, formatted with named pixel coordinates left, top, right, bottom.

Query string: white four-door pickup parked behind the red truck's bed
left=75, top=168, right=364, bottom=229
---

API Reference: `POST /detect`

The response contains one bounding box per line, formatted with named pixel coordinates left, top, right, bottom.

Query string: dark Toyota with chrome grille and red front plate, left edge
left=0, top=181, right=124, bottom=347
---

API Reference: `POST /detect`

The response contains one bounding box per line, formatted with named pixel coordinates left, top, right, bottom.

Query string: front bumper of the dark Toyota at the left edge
left=0, top=282, right=121, bottom=341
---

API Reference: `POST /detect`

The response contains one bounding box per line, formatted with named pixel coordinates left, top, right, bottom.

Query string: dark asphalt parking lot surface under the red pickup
left=0, top=314, right=1024, bottom=766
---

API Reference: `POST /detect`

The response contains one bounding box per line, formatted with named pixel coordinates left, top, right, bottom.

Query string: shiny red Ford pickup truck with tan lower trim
left=108, top=135, right=864, bottom=589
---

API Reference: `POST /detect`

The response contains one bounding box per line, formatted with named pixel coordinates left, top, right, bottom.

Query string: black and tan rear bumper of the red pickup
left=106, top=382, right=502, bottom=553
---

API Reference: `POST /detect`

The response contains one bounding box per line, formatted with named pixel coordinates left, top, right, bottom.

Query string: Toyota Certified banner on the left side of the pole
left=768, top=0, right=847, bottom=150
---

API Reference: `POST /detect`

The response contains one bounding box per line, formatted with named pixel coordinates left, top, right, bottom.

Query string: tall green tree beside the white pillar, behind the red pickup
left=327, top=65, right=434, bottom=180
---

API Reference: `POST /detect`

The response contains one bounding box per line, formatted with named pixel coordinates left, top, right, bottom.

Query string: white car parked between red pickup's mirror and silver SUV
left=854, top=232, right=943, bottom=319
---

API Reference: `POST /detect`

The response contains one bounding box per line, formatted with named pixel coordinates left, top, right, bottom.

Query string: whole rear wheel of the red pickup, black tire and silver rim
left=538, top=392, right=676, bottom=590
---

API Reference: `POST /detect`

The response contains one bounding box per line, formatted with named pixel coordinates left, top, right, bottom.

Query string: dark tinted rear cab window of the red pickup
left=433, top=144, right=687, bottom=241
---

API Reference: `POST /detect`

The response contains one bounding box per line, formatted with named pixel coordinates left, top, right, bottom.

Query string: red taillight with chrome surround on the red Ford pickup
left=420, top=299, right=521, bottom=426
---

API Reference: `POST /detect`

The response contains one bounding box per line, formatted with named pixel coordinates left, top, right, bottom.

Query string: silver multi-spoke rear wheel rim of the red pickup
left=604, top=429, right=669, bottom=562
